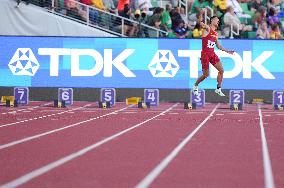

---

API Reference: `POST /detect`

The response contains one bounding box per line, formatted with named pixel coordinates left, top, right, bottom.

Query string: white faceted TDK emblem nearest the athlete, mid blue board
left=148, top=50, right=179, bottom=77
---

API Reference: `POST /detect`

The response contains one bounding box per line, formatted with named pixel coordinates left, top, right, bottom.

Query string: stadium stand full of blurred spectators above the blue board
left=10, top=0, right=284, bottom=39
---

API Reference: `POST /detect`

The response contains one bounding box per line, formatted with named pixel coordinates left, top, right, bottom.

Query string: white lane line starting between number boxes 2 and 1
left=258, top=106, right=275, bottom=188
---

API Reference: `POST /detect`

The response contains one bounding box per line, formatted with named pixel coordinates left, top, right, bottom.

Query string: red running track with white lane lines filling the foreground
left=0, top=104, right=284, bottom=187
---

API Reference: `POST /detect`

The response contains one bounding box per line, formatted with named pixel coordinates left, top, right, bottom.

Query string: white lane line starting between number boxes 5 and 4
left=0, top=107, right=133, bottom=150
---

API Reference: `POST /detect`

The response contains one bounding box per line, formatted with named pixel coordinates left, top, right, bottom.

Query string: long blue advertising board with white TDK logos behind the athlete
left=0, top=36, right=284, bottom=89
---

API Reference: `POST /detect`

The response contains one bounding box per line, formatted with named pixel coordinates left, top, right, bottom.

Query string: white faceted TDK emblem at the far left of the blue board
left=8, top=48, right=39, bottom=76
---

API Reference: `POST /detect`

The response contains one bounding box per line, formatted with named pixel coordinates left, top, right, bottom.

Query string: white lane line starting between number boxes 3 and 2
left=135, top=103, right=220, bottom=188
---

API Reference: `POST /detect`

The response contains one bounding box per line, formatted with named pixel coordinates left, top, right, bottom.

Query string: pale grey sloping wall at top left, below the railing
left=0, top=0, right=116, bottom=37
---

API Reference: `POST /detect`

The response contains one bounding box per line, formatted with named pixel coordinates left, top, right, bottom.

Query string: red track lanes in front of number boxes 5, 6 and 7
left=0, top=102, right=125, bottom=144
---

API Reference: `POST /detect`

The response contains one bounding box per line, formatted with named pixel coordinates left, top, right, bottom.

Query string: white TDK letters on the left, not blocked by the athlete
left=38, top=48, right=136, bottom=77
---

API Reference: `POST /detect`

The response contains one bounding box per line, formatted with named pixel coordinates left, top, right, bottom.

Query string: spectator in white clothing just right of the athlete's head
left=224, top=6, right=252, bottom=37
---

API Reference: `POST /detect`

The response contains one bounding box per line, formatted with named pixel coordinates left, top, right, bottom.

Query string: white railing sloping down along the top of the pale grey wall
left=40, top=0, right=168, bottom=37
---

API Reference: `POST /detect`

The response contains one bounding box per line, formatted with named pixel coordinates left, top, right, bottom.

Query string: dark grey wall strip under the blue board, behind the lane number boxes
left=0, top=87, right=273, bottom=103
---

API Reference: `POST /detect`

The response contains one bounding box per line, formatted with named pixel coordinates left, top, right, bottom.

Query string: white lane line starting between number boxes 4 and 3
left=0, top=103, right=178, bottom=188
